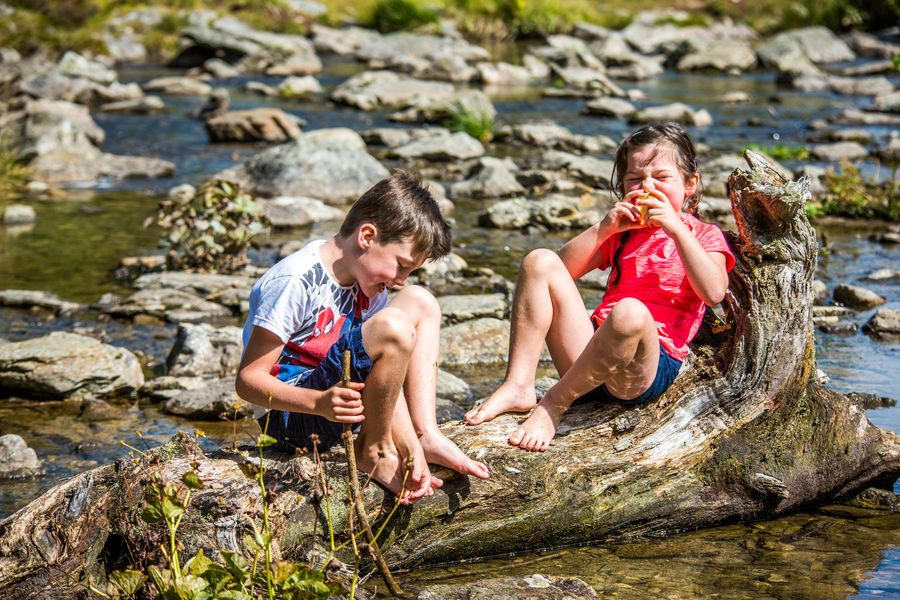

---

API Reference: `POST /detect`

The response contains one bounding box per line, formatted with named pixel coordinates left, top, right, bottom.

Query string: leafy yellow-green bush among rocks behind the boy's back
left=148, top=180, right=266, bottom=273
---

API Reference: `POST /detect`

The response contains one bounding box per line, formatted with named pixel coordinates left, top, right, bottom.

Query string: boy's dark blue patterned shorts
left=259, top=326, right=372, bottom=452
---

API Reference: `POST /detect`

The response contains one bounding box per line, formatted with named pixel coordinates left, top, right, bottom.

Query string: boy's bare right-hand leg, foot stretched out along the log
left=390, top=286, right=488, bottom=479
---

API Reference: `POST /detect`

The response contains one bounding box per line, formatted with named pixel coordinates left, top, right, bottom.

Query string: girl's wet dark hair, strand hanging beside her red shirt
left=607, top=121, right=703, bottom=287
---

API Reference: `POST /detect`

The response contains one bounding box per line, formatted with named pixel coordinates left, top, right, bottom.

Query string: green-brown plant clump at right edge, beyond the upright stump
left=808, top=161, right=900, bottom=221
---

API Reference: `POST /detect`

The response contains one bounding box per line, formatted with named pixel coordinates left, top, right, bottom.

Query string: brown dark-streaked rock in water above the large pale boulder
left=206, top=108, right=301, bottom=143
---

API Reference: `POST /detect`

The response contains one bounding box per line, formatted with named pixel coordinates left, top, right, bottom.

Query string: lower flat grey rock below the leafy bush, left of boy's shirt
left=102, top=288, right=232, bottom=323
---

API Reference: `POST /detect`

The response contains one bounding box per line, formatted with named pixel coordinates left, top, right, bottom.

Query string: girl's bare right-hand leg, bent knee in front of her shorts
left=509, top=298, right=659, bottom=451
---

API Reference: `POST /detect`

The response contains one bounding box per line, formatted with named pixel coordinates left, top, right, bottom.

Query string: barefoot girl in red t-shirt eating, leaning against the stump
left=465, top=122, right=734, bottom=451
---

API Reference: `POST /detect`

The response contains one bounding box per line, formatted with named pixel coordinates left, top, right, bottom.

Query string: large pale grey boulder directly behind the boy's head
left=215, top=134, right=390, bottom=204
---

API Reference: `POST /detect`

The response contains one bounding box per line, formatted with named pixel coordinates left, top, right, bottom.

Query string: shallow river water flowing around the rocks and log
left=0, top=54, right=900, bottom=598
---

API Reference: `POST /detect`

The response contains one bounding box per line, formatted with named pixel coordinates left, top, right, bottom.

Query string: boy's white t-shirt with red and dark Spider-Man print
left=244, top=240, right=387, bottom=367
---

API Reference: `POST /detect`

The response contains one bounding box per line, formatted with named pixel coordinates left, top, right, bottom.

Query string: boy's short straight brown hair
left=339, top=171, right=451, bottom=259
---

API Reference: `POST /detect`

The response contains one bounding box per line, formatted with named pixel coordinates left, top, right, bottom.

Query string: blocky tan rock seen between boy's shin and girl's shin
left=438, top=318, right=509, bottom=367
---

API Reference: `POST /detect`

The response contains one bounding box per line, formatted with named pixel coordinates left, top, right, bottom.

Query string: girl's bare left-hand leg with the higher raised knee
left=465, top=249, right=593, bottom=425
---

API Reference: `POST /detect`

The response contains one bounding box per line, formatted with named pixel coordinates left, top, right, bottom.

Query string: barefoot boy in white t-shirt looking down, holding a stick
left=235, top=172, right=488, bottom=503
